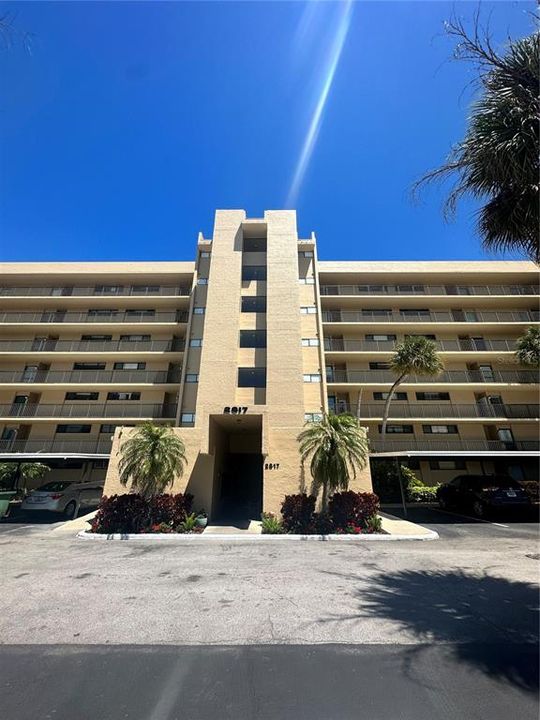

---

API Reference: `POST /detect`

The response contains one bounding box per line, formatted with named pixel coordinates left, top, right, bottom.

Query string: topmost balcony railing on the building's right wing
left=321, top=283, right=539, bottom=295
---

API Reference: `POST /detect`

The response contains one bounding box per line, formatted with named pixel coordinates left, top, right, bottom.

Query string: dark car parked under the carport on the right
left=437, top=475, right=531, bottom=517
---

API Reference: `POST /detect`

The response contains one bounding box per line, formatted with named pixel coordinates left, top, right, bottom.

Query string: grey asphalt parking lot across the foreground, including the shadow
left=0, top=507, right=540, bottom=720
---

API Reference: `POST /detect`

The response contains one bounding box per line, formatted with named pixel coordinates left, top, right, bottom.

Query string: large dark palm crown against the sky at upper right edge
left=414, top=15, right=540, bottom=263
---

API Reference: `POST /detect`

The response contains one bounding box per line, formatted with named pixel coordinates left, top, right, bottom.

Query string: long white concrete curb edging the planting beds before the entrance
left=77, top=530, right=439, bottom=544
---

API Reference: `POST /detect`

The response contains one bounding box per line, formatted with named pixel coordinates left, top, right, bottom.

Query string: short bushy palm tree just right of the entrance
left=298, top=413, right=369, bottom=512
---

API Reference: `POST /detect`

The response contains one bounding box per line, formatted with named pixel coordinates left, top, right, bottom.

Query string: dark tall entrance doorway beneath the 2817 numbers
left=210, top=415, right=263, bottom=525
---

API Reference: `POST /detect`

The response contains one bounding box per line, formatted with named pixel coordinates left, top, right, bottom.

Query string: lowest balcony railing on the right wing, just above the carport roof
left=370, top=435, right=540, bottom=453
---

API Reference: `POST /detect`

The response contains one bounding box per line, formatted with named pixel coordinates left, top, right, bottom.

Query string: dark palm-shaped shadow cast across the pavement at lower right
left=322, top=570, right=540, bottom=692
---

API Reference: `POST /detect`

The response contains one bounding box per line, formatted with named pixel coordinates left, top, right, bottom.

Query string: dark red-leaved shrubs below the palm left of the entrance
left=90, top=493, right=193, bottom=534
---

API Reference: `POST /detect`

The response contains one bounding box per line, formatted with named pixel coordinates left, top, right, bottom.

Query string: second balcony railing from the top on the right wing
left=322, top=310, right=540, bottom=324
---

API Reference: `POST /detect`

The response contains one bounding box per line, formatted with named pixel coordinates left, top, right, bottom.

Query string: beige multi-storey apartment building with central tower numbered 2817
left=0, top=210, right=540, bottom=517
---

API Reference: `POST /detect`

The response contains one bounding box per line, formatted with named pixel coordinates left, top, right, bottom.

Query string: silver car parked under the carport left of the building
left=21, top=480, right=103, bottom=518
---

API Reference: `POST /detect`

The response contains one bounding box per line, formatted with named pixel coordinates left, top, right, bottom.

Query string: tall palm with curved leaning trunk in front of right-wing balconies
left=381, top=335, right=444, bottom=441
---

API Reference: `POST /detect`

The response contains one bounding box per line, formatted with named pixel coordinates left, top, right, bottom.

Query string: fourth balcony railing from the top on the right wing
left=326, top=370, right=540, bottom=385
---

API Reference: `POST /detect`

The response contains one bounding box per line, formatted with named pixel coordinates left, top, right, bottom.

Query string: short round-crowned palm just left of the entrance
left=118, top=422, right=187, bottom=498
